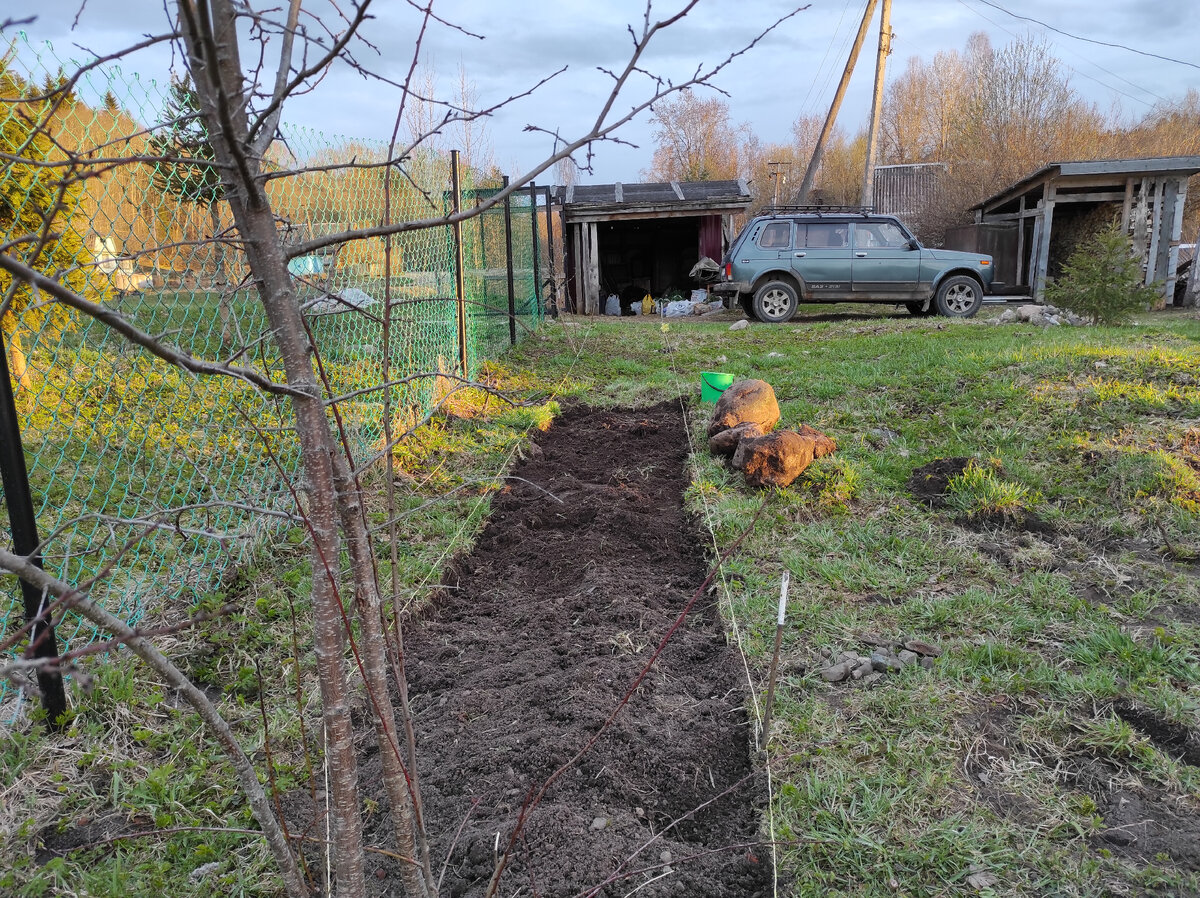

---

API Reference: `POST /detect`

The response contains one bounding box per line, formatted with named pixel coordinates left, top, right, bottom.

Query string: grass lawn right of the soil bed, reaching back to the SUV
left=518, top=306, right=1200, bottom=896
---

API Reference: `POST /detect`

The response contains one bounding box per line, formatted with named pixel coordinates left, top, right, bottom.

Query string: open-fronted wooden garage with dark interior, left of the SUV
left=554, top=180, right=751, bottom=315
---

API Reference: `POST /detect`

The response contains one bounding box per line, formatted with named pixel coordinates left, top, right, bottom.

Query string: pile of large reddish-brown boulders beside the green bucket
left=708, top=381, right=838, bottom=487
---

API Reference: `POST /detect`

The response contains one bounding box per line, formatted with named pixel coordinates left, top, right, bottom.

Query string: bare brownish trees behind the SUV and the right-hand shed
left=643, top=34, right=1200, bottom=237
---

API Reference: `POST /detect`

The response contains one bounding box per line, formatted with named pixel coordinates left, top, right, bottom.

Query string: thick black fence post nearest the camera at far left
left=0, top=328, right=67, bottom=725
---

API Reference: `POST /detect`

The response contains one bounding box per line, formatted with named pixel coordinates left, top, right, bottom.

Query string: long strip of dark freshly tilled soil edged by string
left=365, top=402, right=770, bottom=898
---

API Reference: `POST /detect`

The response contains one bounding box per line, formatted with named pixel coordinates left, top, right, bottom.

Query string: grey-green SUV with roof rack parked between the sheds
left=713, top=206, right=994, bottom=323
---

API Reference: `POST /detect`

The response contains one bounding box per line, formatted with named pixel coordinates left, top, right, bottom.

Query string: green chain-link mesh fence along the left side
left=0, top=35, right=541, bottom=719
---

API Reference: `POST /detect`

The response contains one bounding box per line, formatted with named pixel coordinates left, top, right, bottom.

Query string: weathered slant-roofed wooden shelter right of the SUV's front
left=947, top=156, right=1200, bottom=301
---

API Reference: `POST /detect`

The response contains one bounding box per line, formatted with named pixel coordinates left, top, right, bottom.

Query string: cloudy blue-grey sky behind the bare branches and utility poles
left=9, top=0, right=1200, bottom=182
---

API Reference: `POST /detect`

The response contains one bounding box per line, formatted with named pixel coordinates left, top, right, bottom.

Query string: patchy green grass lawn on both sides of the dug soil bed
left=0, top=306, right=1200, bottom=896
